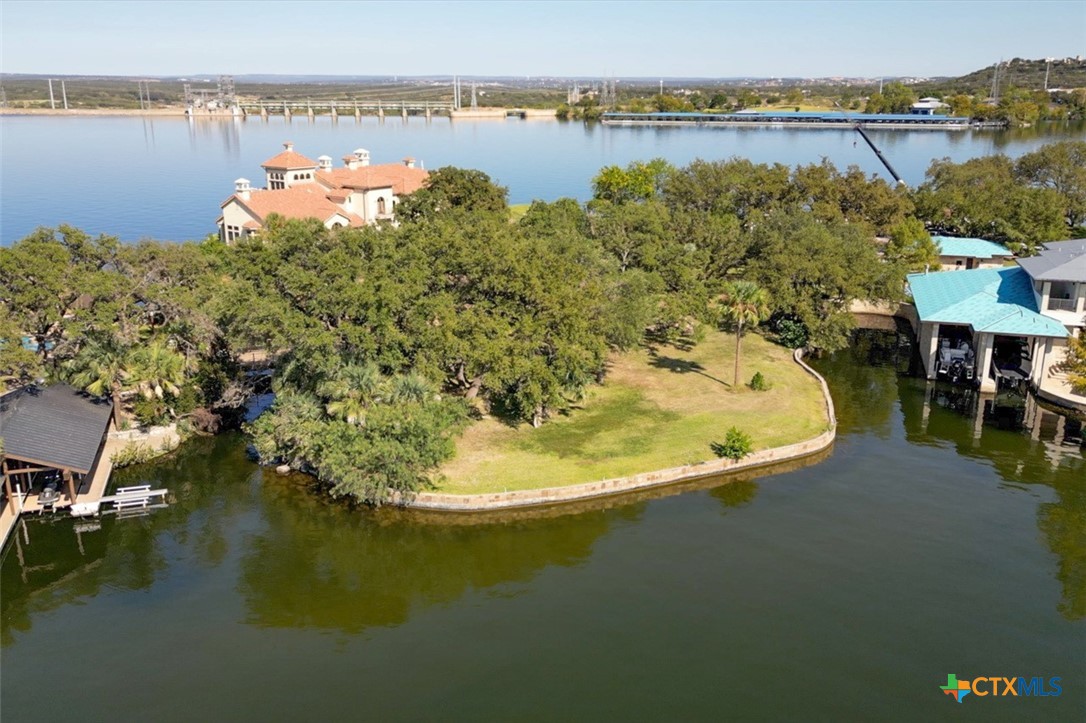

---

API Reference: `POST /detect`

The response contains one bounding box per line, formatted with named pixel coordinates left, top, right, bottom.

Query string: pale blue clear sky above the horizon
left=6, top=0, right=1086, bottom=77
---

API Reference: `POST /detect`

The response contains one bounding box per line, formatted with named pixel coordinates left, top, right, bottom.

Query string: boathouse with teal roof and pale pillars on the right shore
left=909, top=239, right=1086, bottom=392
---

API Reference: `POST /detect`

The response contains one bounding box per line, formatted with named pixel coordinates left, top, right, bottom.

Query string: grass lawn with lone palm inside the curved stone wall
left=438, top=331, right=828, bottom=494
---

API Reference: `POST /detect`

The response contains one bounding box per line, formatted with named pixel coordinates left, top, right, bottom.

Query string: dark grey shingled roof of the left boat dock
left=0, top=384, right=113, bottom=474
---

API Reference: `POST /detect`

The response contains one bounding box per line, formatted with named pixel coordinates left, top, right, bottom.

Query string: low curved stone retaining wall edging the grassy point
left=407, top=350, right=837, bottom=505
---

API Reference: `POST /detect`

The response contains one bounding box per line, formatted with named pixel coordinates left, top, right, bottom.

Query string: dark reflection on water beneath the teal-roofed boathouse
left=816, top=330, right=1086, bottom=620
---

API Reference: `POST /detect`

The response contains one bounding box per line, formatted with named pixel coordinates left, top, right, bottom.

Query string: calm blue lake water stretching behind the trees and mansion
left=0, top=116, right=1086, bottom=244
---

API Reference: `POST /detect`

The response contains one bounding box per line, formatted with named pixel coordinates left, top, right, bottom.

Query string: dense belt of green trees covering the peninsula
left=0, top=142, right=1086, bottom=504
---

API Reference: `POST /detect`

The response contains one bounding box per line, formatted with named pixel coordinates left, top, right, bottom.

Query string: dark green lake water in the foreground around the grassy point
left=0, top=333, right=1086, bottom=722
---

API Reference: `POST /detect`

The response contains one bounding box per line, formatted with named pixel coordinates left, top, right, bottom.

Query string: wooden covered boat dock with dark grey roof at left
left=0, top=384, right=113, bottom=541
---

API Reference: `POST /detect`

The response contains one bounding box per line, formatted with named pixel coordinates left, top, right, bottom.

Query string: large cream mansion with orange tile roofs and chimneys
left=218, top=142, right=429, bottom=243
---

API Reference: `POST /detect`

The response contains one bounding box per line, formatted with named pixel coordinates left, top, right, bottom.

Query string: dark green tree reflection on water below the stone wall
left=238, top=481, right=641, bottom=633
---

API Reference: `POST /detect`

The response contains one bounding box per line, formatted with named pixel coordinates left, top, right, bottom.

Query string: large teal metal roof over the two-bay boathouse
left=909, top=266, right=1068, bottom=339
